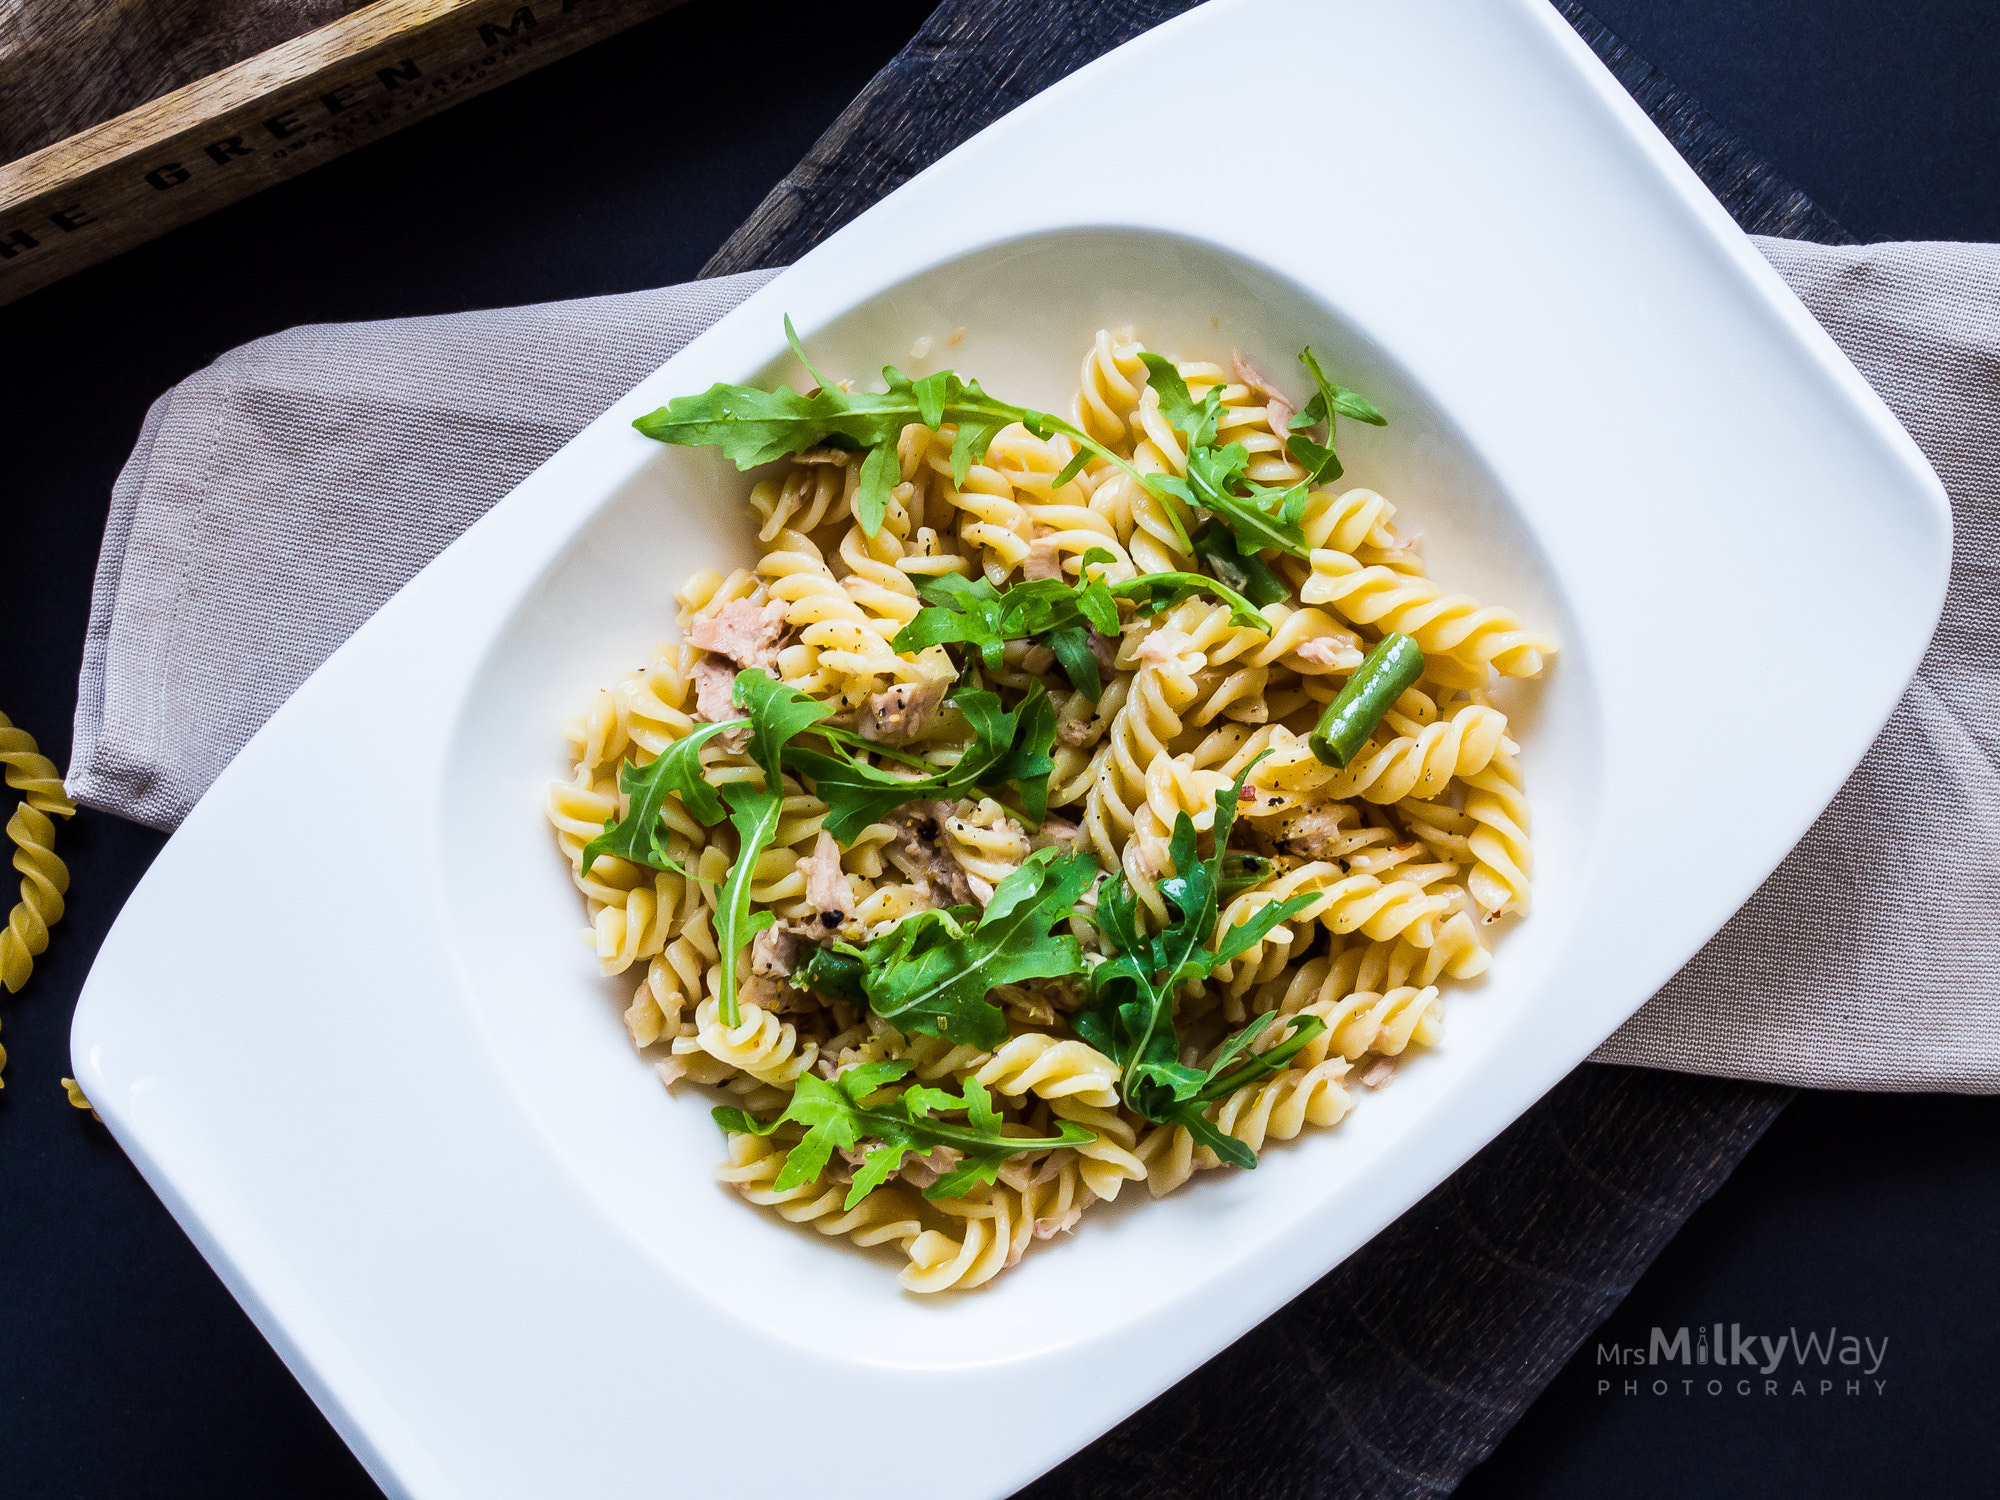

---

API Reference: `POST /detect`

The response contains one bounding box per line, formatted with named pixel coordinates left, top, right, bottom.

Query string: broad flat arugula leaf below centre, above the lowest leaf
left=844, top=848, right=1098, bottom=1048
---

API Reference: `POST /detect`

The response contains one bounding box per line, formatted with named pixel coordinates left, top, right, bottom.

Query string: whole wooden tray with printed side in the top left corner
left=0, top=0, right=680, bottom=304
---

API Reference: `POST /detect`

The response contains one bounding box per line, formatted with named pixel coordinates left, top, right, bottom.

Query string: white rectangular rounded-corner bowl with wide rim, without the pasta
left=74, top=0, right=1950, bottom=1496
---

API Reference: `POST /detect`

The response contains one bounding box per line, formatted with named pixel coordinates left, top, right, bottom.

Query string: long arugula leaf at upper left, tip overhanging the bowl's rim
left=632, top=318, right=1168, bottom=536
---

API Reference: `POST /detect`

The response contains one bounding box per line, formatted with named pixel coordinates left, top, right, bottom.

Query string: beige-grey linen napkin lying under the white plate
left=68, top=240, right=2000, bottom=1092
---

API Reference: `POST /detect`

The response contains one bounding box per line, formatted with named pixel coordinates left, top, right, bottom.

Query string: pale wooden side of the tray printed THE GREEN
left=0, top=0, right=680, bottom=302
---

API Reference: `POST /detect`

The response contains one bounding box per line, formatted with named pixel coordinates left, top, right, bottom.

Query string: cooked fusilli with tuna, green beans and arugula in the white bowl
left=546, top=332, right=1556, bottom=1292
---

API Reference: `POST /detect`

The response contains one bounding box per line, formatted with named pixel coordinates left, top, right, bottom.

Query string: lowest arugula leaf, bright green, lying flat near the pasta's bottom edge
left=712, top=1058, right=1094, bottom=1208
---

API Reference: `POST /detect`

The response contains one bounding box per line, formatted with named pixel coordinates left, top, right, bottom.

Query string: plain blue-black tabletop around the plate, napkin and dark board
left=0, top=0, right=2000, bottom=1500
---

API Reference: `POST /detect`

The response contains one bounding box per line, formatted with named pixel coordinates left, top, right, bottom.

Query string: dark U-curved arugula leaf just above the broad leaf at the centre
left=784, top=682, right=1056, bottom=844
